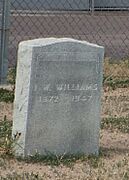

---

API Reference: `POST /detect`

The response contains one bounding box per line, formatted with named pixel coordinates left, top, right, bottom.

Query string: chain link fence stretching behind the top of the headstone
left=9, top=0, right=129, bottom=65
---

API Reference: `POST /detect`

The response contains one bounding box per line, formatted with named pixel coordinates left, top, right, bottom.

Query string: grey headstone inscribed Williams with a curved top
left=13, top=38, right=104, bottom=156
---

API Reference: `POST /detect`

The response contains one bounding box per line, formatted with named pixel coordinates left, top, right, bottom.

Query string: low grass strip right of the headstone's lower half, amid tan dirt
left=101, top=117, right=129, bottom=133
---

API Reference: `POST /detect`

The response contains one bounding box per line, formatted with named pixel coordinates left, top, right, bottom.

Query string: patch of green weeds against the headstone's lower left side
left=0, top=116, right=17, bottom=156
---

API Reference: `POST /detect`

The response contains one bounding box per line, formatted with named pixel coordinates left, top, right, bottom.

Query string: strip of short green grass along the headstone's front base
left=17, top=153, right=102, bottom=168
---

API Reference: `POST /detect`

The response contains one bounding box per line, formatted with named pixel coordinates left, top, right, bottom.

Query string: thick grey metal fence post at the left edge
left=0, top=0, right=10, bottom=84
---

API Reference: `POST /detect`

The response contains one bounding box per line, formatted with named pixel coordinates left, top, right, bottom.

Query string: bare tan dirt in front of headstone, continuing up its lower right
left=0, top=130, right=129, bottom=180
